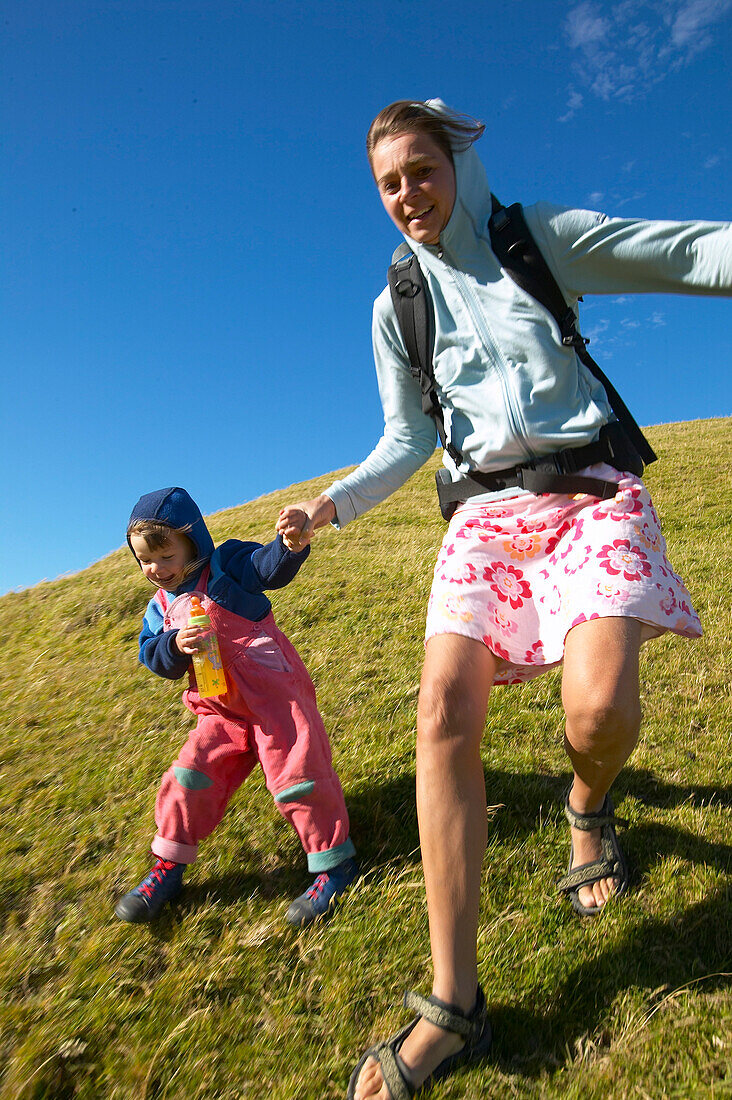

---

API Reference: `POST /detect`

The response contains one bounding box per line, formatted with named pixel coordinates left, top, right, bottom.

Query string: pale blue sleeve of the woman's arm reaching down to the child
left=326, top=289, right=437, bottom=528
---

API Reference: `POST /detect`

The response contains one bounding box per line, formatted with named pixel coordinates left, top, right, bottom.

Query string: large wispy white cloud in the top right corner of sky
left=561, top=0, right=732, bottom=105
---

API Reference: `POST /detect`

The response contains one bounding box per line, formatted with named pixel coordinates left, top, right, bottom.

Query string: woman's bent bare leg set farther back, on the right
left=561, top=618, right=641, bottom=908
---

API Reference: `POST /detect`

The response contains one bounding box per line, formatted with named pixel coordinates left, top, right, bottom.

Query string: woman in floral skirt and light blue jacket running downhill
left=278, top=100, right=732, bottom=1100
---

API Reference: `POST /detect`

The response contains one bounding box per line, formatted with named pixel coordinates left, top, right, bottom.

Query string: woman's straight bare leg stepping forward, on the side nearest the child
left=356, top=635, right=496, bottom=1100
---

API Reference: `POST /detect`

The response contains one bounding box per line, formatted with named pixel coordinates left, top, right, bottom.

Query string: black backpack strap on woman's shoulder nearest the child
left=387, top=243, right=462, bottom=465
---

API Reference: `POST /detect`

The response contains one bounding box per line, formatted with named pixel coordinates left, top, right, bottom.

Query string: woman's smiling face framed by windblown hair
left=371, top=133, right=455, bottom=244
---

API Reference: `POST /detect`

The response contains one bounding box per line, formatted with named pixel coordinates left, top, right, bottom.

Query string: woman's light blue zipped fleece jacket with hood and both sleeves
left=326, top=100, right=732, bottom=527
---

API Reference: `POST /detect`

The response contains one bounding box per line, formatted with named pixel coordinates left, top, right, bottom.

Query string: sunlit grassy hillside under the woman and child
left=0, top=420, right=732, bottom=1100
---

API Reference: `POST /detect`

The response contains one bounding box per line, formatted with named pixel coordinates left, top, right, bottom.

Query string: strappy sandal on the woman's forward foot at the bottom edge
left=348, top=986, right=493, bottom=1100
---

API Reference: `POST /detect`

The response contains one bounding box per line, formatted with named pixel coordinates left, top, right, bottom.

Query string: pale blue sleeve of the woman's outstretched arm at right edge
left=525, top=202, right=732, bottom=298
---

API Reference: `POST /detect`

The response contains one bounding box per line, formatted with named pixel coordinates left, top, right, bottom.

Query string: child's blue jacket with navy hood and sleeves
left=128, top=486, right=310, bottom=680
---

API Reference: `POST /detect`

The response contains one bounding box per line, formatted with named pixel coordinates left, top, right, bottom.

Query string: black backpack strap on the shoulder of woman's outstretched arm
left=488, top=195, right=656, bottom=465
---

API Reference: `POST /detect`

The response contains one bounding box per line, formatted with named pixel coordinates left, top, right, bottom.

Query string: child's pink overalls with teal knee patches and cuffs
left=152, top=569, right=354, bottom=873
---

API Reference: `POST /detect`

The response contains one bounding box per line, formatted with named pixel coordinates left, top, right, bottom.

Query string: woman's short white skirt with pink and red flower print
left=426, top=463, right=701, bottom=684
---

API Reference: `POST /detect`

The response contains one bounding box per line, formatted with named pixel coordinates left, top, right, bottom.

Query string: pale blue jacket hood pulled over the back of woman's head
left=404, top=99, right=491, bottom=259
